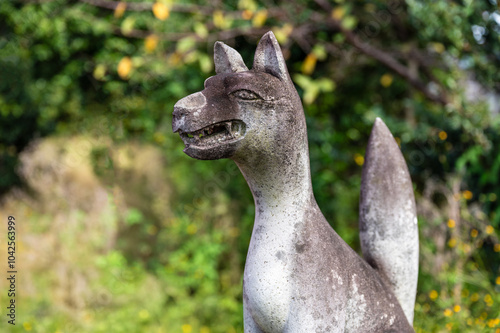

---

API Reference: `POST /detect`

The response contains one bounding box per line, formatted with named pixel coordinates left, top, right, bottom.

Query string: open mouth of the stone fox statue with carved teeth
left=179, top=120, right=246, bottom=148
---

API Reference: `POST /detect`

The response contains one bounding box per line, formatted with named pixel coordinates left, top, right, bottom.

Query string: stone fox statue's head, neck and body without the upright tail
left=172, top=32, right=413, bottom=333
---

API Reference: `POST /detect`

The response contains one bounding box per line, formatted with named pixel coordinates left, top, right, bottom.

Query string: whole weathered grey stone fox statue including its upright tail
left=172, top=32, right=418, bottom=333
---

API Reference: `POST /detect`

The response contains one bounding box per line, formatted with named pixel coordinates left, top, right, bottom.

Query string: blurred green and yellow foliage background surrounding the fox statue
left=0, top=0, right=500, bottom=333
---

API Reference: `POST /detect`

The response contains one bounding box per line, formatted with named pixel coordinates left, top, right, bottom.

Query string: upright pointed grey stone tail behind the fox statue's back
left=359, top=118, right=419, bottom=324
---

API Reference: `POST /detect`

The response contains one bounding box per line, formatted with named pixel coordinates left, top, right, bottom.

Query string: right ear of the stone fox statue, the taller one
left=252, top=31, right=290, bottom=80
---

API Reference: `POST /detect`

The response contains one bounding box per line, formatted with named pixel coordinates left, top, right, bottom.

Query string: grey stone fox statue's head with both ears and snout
left=172, top=32, right=307, bottom=162
